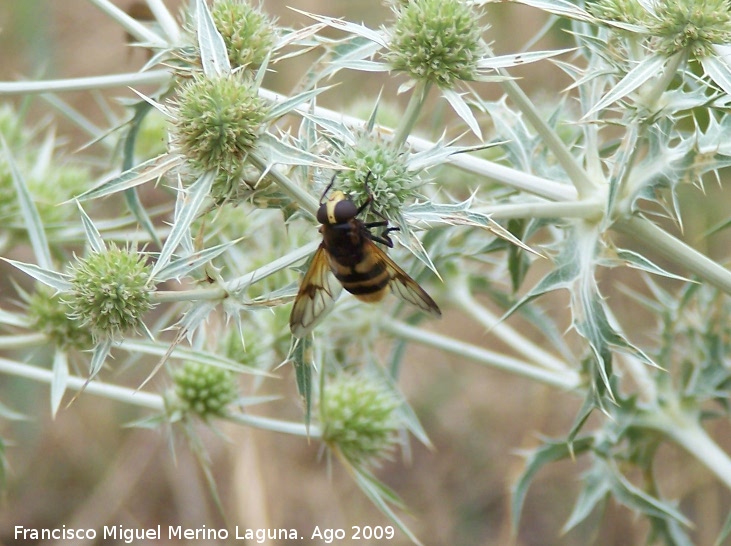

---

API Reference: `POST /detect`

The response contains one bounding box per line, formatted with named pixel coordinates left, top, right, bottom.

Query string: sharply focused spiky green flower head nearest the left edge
left=64, top=245, right=152, bottom=339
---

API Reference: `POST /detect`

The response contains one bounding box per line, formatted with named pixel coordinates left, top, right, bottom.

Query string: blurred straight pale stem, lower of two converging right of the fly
left=382, top=317, right=582, bottom=391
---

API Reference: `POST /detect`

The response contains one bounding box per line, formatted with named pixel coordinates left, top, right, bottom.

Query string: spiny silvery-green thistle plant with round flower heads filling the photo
left=0, top=0, right=731, bottom=544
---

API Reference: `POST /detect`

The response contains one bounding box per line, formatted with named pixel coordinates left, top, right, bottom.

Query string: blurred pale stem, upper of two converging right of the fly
left=450, top=279, right=570, bottom=372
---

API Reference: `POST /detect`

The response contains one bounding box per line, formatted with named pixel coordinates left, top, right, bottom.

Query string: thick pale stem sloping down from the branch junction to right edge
left=613, top=217, right=731, bottom=295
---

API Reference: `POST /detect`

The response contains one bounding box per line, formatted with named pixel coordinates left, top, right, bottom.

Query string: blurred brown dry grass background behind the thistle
left=0, top=0, right=728, bottom=546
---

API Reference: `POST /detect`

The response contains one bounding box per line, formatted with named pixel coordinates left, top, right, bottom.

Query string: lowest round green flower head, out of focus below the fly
left=320, top=375, right=401, bottom=464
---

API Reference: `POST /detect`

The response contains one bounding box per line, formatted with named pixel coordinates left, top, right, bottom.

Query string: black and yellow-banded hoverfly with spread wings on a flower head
left=289, top=174, right=442, bottom=337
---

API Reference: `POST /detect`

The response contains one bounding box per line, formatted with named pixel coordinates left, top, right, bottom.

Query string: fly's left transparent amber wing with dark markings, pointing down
left=289, top=245, right=344, bottom=337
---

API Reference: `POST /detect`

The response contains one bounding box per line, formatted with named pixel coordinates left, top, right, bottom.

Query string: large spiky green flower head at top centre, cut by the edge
left=386, top=0, right=485, bottom=88
